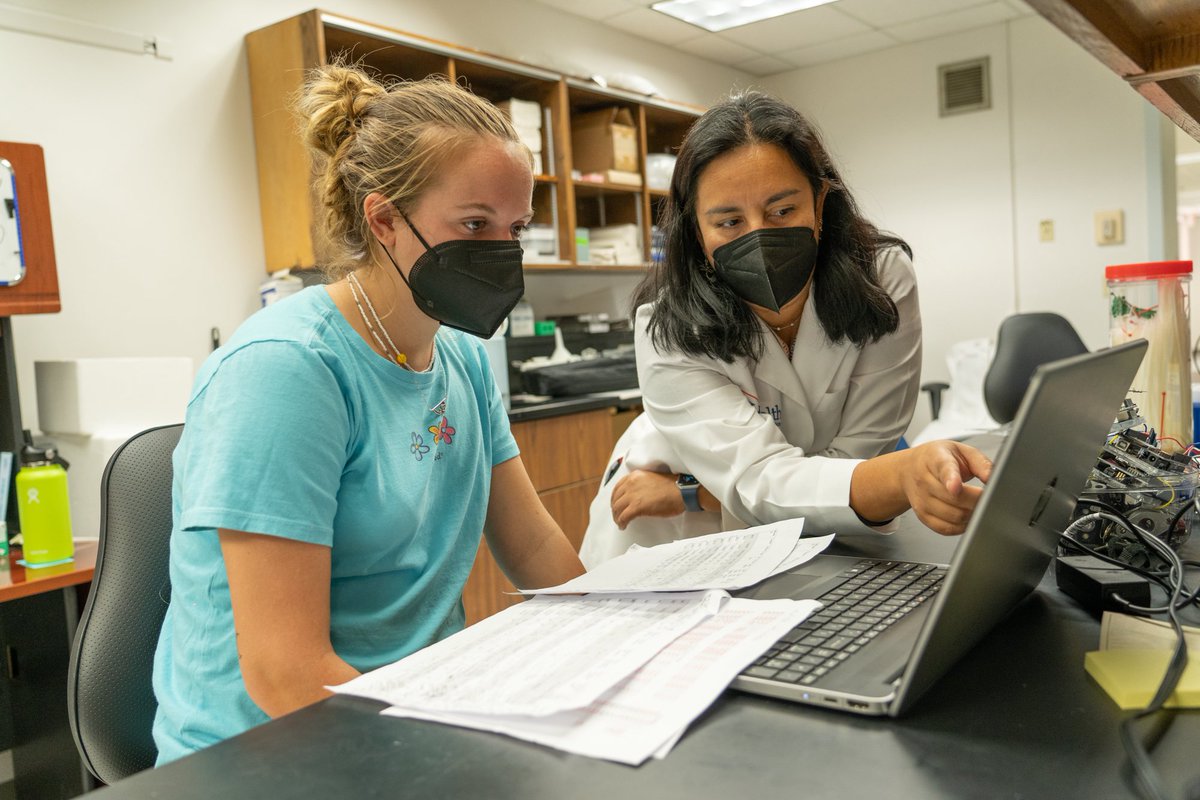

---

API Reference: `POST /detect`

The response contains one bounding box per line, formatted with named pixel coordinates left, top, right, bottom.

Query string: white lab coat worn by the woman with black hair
left=580, top=248, right=920, bottom=569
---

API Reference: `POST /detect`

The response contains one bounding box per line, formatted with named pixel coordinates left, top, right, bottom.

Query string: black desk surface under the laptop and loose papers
left=84, top=520, right=1200, bottom=800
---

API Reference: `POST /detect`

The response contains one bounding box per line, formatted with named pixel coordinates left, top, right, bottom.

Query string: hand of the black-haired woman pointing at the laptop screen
left=900, top=441, right=991, bottom=536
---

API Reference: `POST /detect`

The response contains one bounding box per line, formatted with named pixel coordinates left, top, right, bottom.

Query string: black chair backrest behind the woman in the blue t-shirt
left=67, top=425, right=184, bottom=783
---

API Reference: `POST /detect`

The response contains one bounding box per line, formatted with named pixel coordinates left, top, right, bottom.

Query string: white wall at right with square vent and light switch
left=762, top=17, right=1174, bottom=434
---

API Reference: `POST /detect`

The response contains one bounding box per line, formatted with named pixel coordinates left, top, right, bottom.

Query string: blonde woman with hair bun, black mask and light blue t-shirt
left=154, top=65, right=583, bottom=763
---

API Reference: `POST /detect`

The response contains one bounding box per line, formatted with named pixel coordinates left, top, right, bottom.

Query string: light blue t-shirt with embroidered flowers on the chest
left=154, top=287, right=517, bottom=764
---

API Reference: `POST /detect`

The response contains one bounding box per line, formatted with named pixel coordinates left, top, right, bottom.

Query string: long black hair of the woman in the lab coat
left=632, top=91, right=912, bottom=362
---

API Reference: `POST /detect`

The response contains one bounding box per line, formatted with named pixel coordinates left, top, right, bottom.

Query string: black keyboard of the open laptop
left=742, top=560, right=946, bottom=686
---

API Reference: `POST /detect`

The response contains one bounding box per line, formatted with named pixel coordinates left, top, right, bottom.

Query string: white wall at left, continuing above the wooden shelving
left=0, top=0, right=748, bottom=441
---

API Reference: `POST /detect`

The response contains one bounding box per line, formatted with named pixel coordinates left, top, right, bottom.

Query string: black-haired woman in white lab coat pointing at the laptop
left=581, top=91, right=991, bottom=566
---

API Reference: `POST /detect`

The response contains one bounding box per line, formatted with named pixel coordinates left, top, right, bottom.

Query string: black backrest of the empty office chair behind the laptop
left=983, top=312, right=1087, bottom=423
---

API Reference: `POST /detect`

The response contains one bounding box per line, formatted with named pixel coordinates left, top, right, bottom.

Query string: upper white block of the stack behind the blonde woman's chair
left=34, top=357, right=193, bottom=435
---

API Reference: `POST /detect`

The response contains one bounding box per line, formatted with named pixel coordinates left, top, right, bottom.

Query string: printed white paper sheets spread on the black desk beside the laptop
left=331, top=521, right=832, bottom=765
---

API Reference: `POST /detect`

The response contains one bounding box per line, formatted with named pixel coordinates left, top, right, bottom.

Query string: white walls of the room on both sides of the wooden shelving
left=0, top=0, right=1174, bottom=450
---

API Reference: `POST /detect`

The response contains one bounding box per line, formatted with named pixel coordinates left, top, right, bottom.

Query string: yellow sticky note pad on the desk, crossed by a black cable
left=1084, top=650, right=1200, bottom=711
